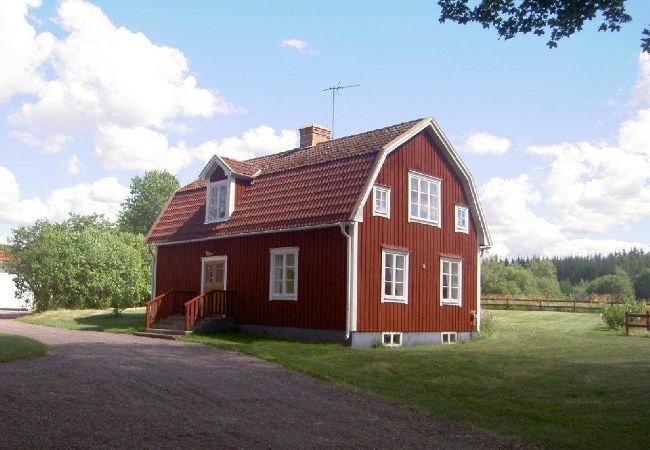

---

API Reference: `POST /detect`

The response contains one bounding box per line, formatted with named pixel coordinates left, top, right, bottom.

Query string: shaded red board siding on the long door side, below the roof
left=156, top=227, right=347, bottom=330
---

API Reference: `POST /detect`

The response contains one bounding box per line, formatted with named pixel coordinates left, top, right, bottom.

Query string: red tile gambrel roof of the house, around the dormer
left=147, top=120, right=420, bottom=244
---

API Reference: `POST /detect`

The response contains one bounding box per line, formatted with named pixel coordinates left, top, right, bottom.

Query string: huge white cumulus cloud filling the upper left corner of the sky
left=0, top=0, right=235, bottom=152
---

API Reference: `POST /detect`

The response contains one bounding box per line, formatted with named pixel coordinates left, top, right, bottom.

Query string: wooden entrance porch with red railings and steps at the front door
left=145, top=289, right=235, bottom=338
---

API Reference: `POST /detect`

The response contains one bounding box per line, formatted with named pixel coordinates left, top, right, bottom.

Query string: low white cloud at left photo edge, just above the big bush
left=0, top=166, right=129, bottom=225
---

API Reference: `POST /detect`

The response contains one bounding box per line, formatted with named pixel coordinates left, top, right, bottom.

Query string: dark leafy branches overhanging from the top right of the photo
left=438, top=0, right=650, bottom=53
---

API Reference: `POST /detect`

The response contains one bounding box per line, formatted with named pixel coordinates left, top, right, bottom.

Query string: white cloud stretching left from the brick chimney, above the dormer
left=95, top=125, right=298, bottom=173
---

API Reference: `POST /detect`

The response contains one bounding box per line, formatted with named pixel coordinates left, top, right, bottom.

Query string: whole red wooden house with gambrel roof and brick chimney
left=147, top=118, right=490, bottom=347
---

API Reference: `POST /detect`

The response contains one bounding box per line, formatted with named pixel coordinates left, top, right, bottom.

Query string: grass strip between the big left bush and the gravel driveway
left=18, top=308, right=145, bottom=333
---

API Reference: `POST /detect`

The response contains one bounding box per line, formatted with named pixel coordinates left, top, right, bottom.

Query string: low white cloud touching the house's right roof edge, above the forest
left=481, top=174, right=650, bottom=257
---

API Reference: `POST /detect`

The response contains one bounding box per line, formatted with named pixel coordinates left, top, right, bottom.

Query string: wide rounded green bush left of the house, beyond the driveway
left=7, top=216, right=151, bottom=314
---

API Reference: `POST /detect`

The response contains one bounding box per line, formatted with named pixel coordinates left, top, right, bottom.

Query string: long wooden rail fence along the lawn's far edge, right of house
left=481, top=295, right=648, bottom=313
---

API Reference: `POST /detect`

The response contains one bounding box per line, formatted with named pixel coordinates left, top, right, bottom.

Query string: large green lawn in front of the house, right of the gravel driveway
left=184, top=311, right=650, bottom=449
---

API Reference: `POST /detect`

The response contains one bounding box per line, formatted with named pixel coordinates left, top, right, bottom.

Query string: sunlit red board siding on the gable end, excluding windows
left=357, top=133, right=477, bottom=331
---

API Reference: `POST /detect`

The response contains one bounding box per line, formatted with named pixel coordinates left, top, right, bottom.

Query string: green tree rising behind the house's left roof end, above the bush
left=117, top=170, right=180, bottom=234
